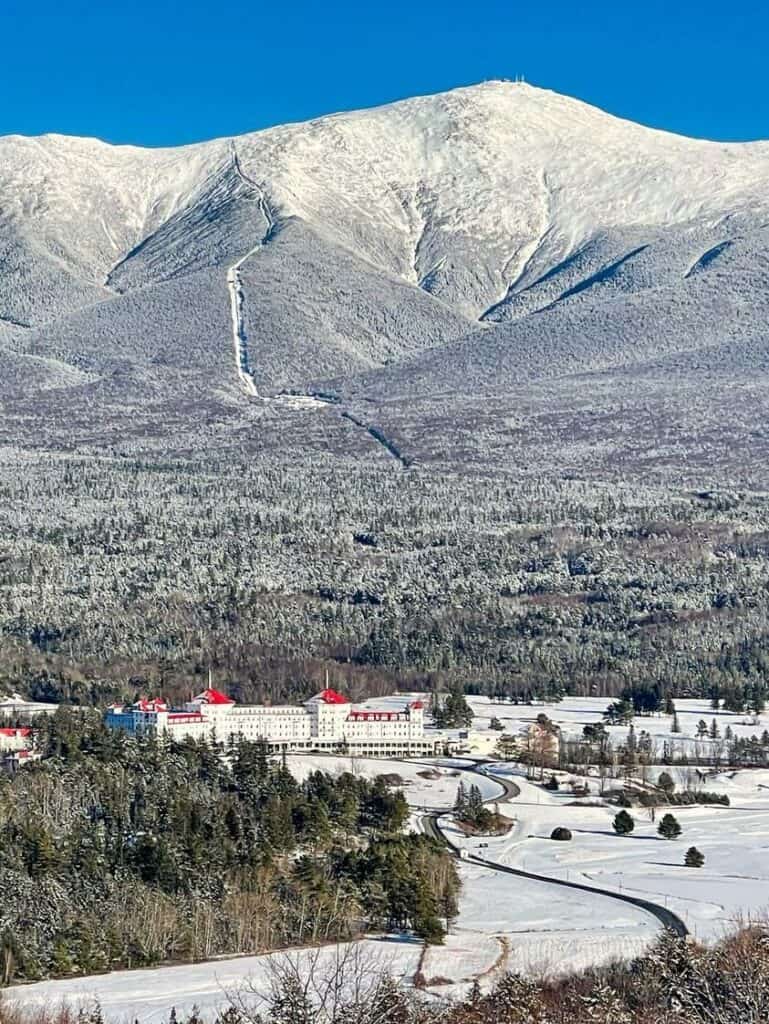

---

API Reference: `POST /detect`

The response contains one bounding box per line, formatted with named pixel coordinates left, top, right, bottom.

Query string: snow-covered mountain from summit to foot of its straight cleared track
left=0, top=82, right=769, bottom=460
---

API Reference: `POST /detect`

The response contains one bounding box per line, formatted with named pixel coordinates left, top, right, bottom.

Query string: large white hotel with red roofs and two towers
left=105, top=687, right=440, bottom=757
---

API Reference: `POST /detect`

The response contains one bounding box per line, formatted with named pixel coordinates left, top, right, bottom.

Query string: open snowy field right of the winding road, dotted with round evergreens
left=447, top=766, right=769, bottom=939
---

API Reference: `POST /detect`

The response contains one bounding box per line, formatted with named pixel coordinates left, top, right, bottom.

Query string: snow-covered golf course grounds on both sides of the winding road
left=6, top=698, right=769, bottom=1024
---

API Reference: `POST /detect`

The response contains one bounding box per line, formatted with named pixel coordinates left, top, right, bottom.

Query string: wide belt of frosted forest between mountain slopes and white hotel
left=0, top=452, right=769, bottom=703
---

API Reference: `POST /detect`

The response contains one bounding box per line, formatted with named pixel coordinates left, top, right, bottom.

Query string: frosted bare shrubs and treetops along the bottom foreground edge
left=0, top=927, right=769, bottom=1024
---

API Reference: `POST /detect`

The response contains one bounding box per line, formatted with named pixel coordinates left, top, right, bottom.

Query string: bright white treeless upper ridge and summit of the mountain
left=0, top=81, right=769, bottom=317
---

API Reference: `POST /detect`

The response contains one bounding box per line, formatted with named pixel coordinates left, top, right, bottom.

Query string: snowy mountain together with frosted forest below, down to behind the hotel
left=0, top=81, right=769, bottom=724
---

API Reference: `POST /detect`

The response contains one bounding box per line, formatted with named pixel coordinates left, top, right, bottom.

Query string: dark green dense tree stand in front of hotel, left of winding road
left=0, top=710, right=458, bottom=983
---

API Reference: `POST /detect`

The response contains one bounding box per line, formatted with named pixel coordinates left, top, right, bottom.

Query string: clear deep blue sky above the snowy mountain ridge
left=0, top=0, right=769, bottom=145
